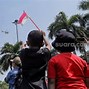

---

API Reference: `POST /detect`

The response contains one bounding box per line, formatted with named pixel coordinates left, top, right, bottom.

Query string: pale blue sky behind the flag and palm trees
left=0, top=0, right=87, bottom=80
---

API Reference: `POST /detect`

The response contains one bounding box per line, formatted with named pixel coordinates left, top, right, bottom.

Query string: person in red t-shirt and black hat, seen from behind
left=48, top=30, right=89, bottom=89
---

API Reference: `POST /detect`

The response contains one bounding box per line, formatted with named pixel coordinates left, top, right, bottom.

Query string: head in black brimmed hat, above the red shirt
left=52, top=30, right=75, bottom=52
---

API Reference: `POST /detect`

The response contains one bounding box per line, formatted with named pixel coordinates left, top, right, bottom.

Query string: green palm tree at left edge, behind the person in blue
left=0, top=42, right=21, bottom=73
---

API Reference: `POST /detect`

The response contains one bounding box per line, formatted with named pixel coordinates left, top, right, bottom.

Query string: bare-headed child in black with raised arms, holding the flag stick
left=19, top=30, right=51, bottom=89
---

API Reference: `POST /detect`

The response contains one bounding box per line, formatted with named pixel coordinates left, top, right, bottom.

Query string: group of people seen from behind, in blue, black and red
left=5, top=30, right=89, bottom=89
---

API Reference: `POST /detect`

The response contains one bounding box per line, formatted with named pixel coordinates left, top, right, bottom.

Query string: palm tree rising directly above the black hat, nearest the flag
left=47, top=12, right=69, bottom=39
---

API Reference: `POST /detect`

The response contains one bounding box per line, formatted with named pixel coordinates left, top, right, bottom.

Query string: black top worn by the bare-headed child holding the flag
left=20, top=48, right=51, bottom=82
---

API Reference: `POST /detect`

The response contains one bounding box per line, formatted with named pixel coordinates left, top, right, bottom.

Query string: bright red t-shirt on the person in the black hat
left=48, top=53, right=87, bottom=89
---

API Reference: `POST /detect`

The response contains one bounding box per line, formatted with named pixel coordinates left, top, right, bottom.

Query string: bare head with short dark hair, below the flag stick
left=27, top=30, right=43, bottom=47
